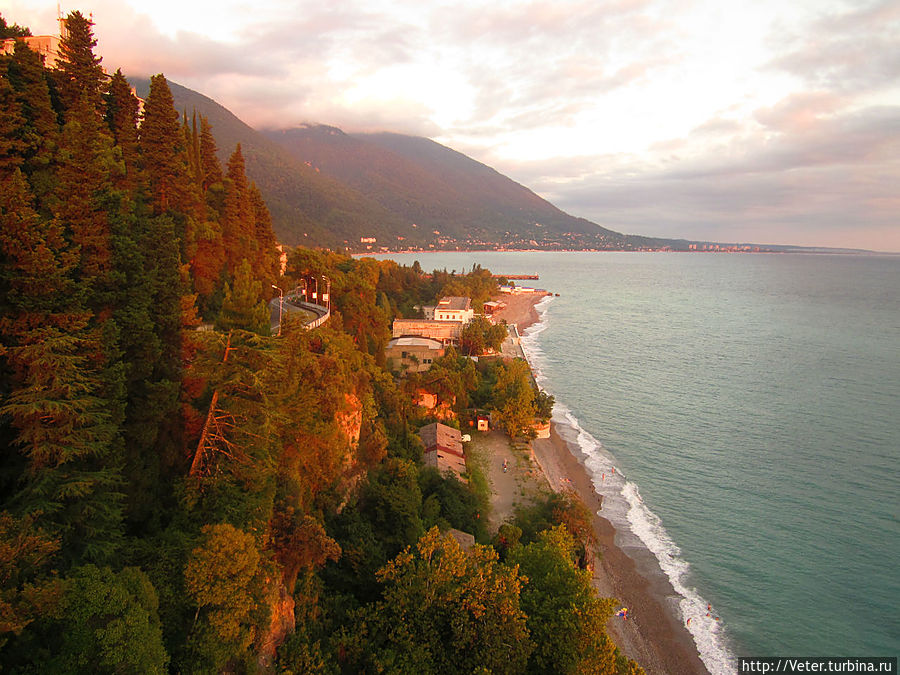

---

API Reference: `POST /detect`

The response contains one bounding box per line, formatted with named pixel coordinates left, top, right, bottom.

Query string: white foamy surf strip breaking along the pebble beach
left=521, top=295, right=737, bottom=675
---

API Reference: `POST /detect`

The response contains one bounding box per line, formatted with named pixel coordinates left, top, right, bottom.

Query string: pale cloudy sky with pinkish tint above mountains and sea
left=7, top=0, right=900, bottom=252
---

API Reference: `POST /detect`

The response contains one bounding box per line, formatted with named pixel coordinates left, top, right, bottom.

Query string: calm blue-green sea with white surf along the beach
left=376, top=252, right=900, bottom=674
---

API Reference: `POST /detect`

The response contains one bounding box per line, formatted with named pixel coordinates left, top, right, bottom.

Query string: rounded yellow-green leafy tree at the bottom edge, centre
left=345, top=528, right=533, bottom=673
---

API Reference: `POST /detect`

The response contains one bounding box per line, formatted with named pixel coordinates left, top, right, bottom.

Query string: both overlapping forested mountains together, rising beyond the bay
left=131, top=78, right=644, bottom=249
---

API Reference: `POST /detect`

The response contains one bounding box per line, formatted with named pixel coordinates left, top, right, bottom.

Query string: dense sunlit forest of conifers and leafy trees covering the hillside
left=0, top=12, right=640, bottom=673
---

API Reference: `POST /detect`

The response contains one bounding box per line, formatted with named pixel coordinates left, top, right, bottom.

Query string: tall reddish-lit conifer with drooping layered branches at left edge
left=0, top=172, right=122, bottom=562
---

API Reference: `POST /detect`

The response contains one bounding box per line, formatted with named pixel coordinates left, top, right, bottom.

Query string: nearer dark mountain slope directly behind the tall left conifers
left=131, top=78, right=403, bottom=246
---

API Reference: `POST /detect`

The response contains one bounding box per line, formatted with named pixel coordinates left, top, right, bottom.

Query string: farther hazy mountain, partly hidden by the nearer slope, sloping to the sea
left=264, top=125, right=625, bottom=244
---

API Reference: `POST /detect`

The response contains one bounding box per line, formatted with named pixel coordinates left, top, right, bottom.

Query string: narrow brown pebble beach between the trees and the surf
left=497, top=293, right=709, bottom=675
